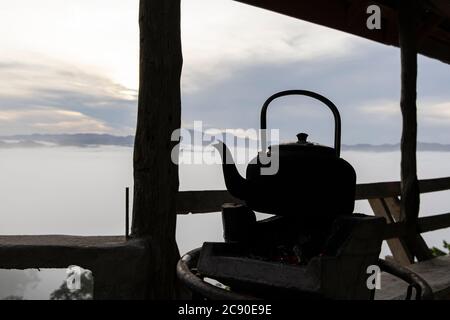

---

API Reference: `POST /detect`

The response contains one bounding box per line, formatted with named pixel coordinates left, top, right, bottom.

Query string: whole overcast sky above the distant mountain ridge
left=0, top=0, right=450, bottom=144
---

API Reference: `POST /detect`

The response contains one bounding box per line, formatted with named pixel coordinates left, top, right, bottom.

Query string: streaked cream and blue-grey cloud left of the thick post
left=0, top=59, right=137, bottom=135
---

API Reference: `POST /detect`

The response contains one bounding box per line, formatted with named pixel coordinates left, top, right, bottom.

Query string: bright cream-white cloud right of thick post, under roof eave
left=181, top=0, right=358, bottom=93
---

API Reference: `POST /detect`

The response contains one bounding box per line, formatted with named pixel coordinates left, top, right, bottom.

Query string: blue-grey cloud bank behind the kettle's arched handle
left=183, top=41, right=450, bottom=145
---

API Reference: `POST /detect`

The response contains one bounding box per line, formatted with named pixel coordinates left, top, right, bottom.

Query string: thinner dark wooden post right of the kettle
left=398, top=0, right=431, bottom=260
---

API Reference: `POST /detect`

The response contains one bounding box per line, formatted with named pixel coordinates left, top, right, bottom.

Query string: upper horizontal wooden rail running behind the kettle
left=177, top=177, right=450, bottom=214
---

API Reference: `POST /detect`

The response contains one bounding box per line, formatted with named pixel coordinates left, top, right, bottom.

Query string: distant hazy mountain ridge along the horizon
left=0, top=133, right=450, bottom=152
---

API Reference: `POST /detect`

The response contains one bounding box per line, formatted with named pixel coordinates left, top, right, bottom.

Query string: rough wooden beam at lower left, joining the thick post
left=0, top=235, right=151, bottom=300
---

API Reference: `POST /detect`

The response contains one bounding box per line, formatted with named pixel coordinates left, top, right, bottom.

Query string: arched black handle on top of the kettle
left=261, top=90, right=341, bottom=158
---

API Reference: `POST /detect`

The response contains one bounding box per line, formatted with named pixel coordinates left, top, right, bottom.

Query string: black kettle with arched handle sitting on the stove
left=214, top=90, right=356, bottom=221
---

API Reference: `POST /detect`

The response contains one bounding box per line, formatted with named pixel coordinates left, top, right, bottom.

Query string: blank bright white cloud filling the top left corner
left=0, top=0, right=139, bottom=89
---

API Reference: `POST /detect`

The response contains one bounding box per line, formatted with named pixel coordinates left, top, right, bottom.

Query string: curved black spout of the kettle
left=212, top=141, right=249, bottom=200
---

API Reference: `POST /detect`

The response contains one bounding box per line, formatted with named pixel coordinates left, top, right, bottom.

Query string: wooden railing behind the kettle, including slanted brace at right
left=177, top=177, right=450, bottom=265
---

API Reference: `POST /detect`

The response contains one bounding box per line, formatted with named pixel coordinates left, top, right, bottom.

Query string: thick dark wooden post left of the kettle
left=132, top=0, right=183, bottom=299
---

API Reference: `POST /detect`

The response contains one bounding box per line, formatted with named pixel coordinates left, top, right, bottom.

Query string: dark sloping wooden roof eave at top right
left=235, top=0, right=450, bottom=64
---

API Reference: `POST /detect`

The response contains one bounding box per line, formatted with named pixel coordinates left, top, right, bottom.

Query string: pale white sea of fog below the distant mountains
left=0, top=147, right=450, bottom=299
